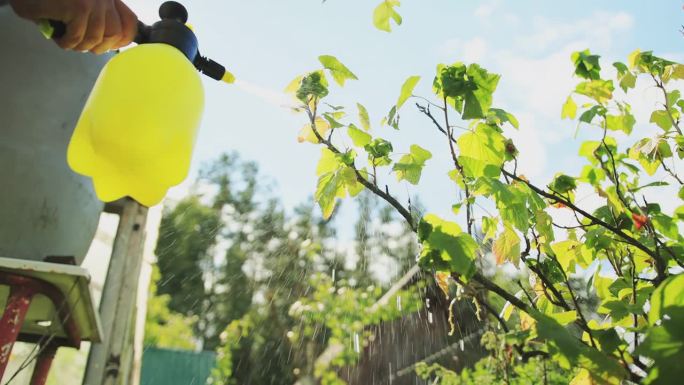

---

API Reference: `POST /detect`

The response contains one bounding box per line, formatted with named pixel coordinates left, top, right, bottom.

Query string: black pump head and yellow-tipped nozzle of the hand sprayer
left=39, top=1, right=232, bottom=83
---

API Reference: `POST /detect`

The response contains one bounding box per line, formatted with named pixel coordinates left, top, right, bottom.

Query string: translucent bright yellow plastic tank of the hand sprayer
left=67, top=44, right=204, bottom=206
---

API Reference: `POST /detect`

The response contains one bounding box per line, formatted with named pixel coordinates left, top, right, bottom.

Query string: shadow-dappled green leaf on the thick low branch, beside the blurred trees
left=418, top=214, right=478, bottom=279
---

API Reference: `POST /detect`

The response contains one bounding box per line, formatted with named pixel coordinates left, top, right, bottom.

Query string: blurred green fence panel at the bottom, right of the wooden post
left=140, top=348, right=216, bottom=385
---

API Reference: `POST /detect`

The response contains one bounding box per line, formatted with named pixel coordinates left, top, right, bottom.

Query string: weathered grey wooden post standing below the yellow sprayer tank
left=83, top=198, right=147, bottom=385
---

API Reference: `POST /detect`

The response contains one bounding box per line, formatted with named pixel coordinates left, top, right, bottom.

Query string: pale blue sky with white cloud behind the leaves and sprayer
left=128, top=0, right=684, bottom=238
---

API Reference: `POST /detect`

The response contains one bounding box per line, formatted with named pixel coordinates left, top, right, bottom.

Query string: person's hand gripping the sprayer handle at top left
left=8, top=0, right=138, bottom=54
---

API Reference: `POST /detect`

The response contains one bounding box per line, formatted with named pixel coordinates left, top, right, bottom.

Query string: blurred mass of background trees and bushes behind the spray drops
left=152, top=148, right=420, bottom=385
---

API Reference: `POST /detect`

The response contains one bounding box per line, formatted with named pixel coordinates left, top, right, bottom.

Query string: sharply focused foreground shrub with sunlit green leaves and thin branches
left=289, top=42, right=684, bottom=384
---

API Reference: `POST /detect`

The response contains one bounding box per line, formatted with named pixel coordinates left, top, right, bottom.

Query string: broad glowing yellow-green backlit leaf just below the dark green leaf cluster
left=457, top=124, right=506, bottom=178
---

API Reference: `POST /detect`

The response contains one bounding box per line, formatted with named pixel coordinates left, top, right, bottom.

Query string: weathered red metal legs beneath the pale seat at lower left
left=0, top=271, right=81, bottom=385
